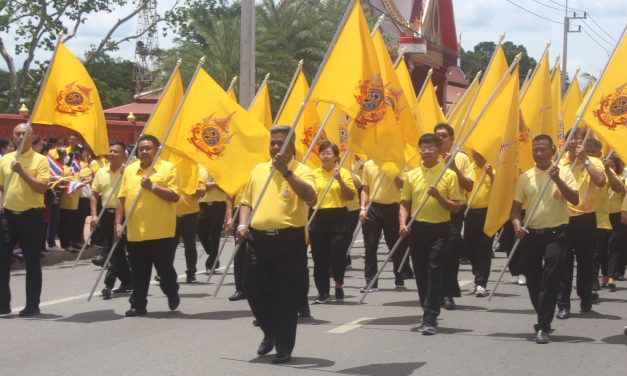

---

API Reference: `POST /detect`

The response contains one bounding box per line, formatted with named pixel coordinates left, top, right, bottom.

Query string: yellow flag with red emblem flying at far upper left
left=30, top=43, right=109, bottom=155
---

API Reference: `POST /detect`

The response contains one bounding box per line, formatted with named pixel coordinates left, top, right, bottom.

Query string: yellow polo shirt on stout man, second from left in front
left=118, top=160, right=179, bottom=242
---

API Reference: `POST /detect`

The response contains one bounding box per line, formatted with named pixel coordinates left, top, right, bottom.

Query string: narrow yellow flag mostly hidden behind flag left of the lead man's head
left=145, top=67, right=198, bottom=195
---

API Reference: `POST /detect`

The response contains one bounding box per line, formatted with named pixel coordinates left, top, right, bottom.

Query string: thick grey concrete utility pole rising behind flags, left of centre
left=239, top=0, right=255, bottom=108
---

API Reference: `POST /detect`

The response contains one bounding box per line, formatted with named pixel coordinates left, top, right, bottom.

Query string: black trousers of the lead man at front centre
left=244, top=227, right=307, bottom=353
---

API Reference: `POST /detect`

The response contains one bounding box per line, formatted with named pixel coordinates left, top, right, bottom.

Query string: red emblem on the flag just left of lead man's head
left=187, top=113, right=234, bottom=159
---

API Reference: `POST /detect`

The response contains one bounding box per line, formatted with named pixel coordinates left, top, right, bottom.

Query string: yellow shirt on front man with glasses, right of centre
left=401, top=163, right=462, bottom=223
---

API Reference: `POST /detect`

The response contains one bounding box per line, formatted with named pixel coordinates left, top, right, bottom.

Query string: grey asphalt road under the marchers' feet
left=0, top=241, right=627, bottom=376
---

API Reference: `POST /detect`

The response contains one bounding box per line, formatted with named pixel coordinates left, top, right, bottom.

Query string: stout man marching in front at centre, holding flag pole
left=237, top=126, right=316, bottom=364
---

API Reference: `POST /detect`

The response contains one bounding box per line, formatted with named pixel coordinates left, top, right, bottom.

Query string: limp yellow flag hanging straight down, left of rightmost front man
left=483, top=67, right=519, bottom=236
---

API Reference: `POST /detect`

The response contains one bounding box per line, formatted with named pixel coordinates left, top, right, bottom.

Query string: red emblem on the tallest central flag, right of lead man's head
left=355, top=74, right=386, bottom=129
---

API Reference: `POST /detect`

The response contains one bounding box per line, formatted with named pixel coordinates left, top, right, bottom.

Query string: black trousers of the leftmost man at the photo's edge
left=0, top=209, right=44, bottom=310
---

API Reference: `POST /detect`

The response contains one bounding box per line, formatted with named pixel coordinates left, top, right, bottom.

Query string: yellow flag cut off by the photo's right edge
left=578, top=31, right=627, bottom=161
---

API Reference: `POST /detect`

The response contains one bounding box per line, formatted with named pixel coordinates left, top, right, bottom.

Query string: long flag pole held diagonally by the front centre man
left=213, top=0, right=356, bottom=296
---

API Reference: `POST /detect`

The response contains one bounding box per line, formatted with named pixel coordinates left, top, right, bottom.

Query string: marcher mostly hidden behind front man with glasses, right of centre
left=433, top=123, right=475, bottom=310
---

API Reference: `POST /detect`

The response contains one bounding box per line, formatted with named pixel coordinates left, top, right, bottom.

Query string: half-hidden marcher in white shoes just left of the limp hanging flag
left=464, top=150, right=494, bottom=298
